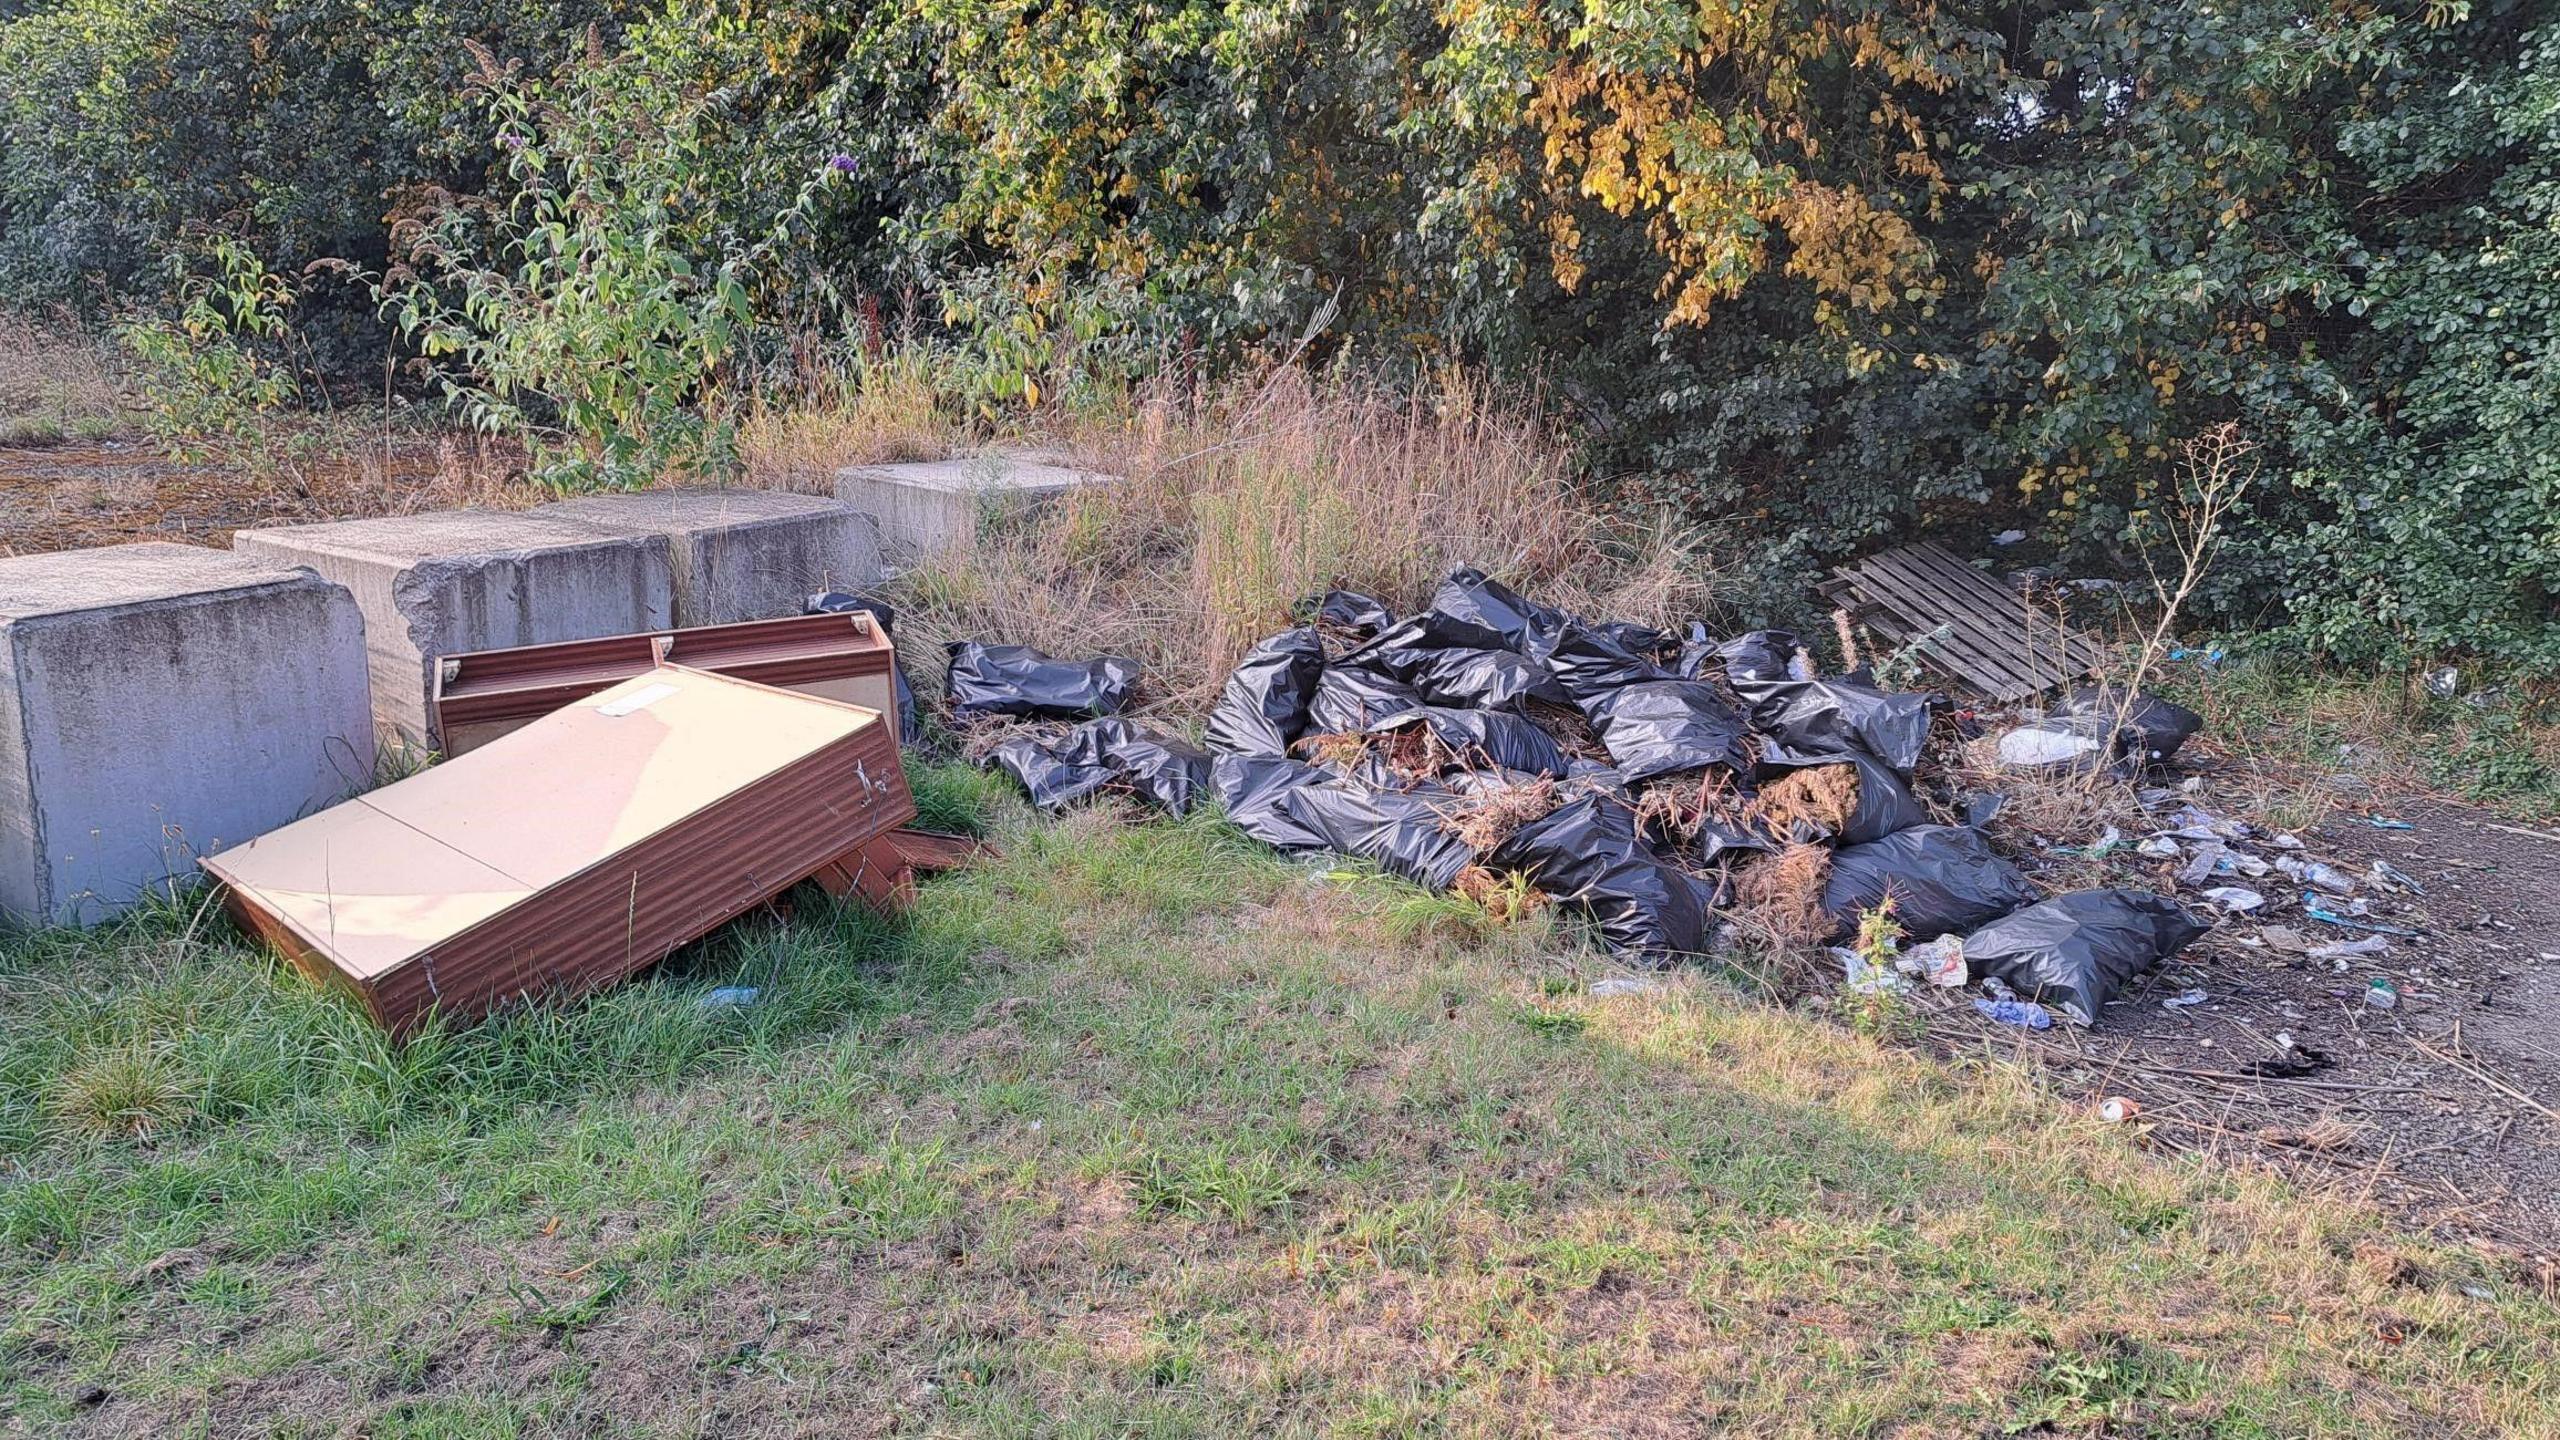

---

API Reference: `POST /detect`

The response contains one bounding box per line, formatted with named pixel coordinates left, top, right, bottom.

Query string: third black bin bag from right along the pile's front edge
left=1485, top=794, right=1713, bottom=963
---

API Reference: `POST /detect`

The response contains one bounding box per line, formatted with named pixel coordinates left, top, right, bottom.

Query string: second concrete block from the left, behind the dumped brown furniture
left=230, top=510, right=673, bottom=746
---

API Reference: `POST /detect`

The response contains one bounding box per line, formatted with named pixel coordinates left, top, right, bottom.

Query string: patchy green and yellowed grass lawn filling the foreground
left=0, top=776, right=2560, bottom=1437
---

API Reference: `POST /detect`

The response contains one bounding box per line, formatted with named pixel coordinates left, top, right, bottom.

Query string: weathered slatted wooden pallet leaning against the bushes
left=1820, top=543, right=2107, bottom=702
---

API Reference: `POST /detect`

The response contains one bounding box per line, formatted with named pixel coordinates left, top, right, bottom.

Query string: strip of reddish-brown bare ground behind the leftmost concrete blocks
left=0, top=436, right=540, bottom=556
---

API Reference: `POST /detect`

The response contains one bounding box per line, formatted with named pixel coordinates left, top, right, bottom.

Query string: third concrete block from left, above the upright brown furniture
left=532, top=489, right=881, bottom=625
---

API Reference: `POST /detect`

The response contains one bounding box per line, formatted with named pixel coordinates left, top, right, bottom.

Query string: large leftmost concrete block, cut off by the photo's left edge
left=0, top=543, right=374, bottom=925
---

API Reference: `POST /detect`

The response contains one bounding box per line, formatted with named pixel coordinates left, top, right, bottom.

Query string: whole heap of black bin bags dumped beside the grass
left=950, top=569, right=2196, bottom=1015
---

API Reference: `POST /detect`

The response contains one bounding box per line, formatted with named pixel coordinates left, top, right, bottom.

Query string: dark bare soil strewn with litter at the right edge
left=1940, top=792, right=2560, bottom=1266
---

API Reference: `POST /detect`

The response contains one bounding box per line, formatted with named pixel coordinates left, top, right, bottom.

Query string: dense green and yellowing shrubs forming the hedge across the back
left=0, top=0, right=2560, bottom=669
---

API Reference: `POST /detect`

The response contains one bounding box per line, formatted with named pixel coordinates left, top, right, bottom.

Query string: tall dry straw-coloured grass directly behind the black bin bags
left=875, top=369, right=1713, bottom=705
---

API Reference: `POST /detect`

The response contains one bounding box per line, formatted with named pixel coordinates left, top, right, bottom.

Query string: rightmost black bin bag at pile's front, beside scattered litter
left=1964, top=889, right=2207, bottom=1025
